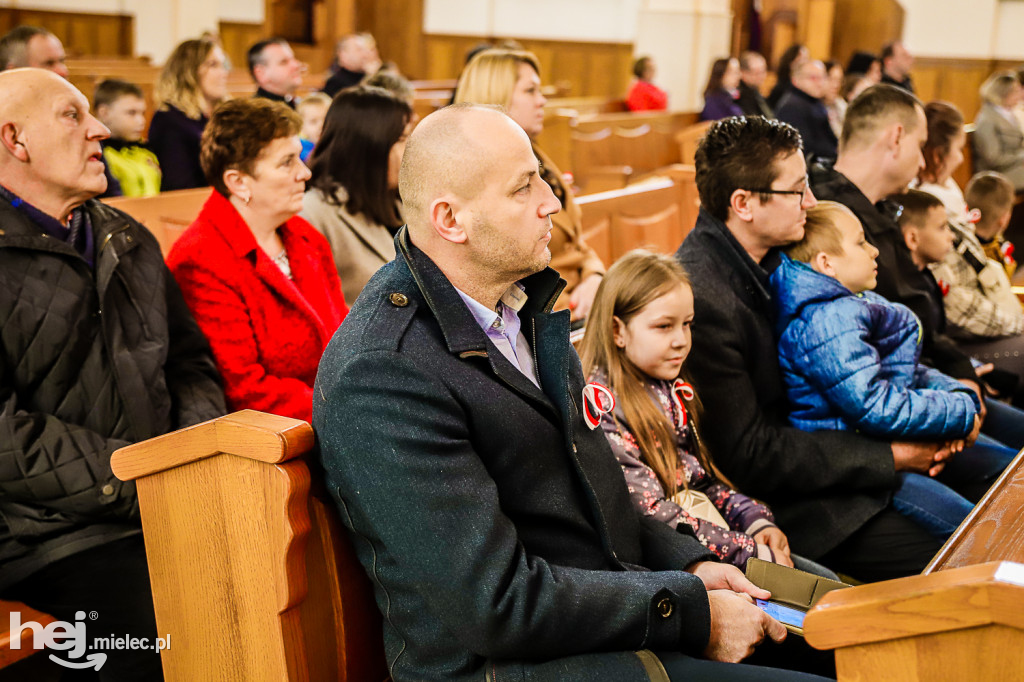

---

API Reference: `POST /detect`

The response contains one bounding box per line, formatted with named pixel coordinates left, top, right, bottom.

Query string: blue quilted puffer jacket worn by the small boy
left=771, top=255, right=979, bottom=439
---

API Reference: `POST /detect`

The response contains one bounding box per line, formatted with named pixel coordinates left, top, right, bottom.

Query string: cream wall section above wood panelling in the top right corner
left=900, top=0, right=1024, bottom=59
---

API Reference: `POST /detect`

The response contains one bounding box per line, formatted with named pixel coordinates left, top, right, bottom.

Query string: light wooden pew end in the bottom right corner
left=804, top=561, right=1024, bottom=682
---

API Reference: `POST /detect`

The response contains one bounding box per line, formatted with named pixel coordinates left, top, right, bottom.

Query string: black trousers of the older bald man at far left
left=0, top=535, right=162, bottom=682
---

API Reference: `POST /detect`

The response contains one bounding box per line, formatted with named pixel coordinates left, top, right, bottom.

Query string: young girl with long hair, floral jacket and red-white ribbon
left=581, top=250, right=830, bottom=574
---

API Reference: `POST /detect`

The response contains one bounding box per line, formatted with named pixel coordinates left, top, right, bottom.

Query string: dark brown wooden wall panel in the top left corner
left=0, top=7, right=135, bottom=56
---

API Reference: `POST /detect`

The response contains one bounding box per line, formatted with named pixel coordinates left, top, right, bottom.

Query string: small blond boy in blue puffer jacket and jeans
left=771, top=202, right=981, bottom=538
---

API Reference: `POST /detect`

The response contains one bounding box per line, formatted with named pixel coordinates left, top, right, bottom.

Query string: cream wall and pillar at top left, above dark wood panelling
left=4, top=0, right=263, bottom=65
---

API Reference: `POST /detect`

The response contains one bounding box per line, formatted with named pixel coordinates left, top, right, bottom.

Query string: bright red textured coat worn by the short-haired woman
left=167, top=187, right=348, bottom=421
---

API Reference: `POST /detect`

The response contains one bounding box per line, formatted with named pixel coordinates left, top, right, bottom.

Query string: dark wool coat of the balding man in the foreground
left=313, top=229, right=713, bottom=682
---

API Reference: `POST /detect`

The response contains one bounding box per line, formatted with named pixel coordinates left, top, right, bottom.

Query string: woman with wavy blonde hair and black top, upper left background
left=150, top=38, right=230, bottom=191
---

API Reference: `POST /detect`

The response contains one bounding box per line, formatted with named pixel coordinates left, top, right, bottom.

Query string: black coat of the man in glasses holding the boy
left=676, top=209, right=896, bottom=559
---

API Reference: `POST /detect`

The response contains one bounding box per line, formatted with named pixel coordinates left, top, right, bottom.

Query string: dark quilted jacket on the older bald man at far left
left=0, top=193, right=224, bottom=587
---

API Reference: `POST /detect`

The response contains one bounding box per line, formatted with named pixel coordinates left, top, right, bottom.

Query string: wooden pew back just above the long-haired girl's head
left=577, top=178, right=693, bottom=264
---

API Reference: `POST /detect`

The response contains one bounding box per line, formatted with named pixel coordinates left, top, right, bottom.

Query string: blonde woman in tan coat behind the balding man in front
left=455, top=49, right=604, bottom=319
